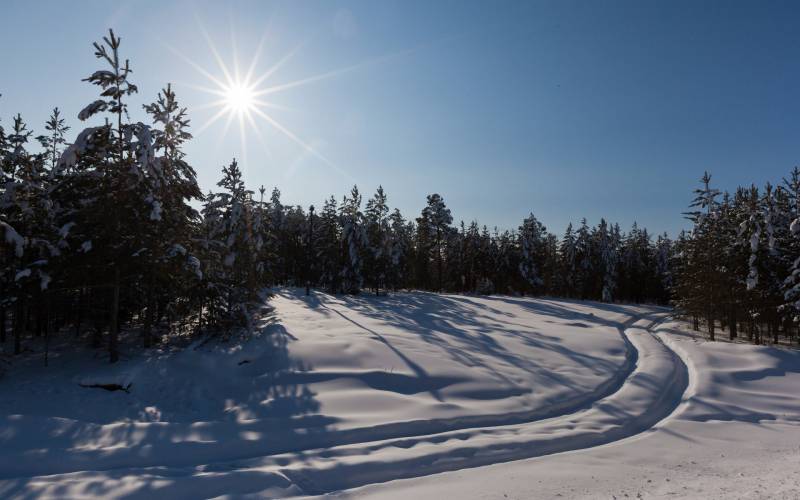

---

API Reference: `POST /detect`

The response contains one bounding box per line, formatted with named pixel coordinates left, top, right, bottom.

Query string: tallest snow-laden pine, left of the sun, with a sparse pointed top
left=67, top=30, right=161, bottom=363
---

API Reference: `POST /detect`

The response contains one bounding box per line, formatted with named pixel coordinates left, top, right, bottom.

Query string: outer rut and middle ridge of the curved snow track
left=0, top=310, right=689, bottom=496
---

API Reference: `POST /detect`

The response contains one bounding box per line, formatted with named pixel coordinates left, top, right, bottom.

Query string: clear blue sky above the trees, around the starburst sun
left=0, top=0, right=800, bottom=234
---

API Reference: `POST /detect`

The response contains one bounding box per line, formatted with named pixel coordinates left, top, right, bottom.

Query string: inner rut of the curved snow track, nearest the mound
left=0, top=311, right=644, bottom=479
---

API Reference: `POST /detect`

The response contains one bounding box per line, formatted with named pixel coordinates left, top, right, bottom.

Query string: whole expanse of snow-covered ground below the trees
left=0, top=290, right=800, bottom=499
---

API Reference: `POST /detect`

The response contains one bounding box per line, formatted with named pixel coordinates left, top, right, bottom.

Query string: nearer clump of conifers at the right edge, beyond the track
left=671, top=168, right=800, bottom=344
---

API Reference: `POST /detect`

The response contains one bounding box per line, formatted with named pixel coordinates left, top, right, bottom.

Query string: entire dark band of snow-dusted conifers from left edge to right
left=0, top=31, right=800, bottom=362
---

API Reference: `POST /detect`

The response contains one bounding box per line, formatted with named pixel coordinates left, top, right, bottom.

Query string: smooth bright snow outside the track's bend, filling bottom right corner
left=346, top=322, right=800, bottom=500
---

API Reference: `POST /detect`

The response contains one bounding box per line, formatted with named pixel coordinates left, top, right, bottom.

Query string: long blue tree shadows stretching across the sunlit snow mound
left=294, top=292, right=664, bottom=394
